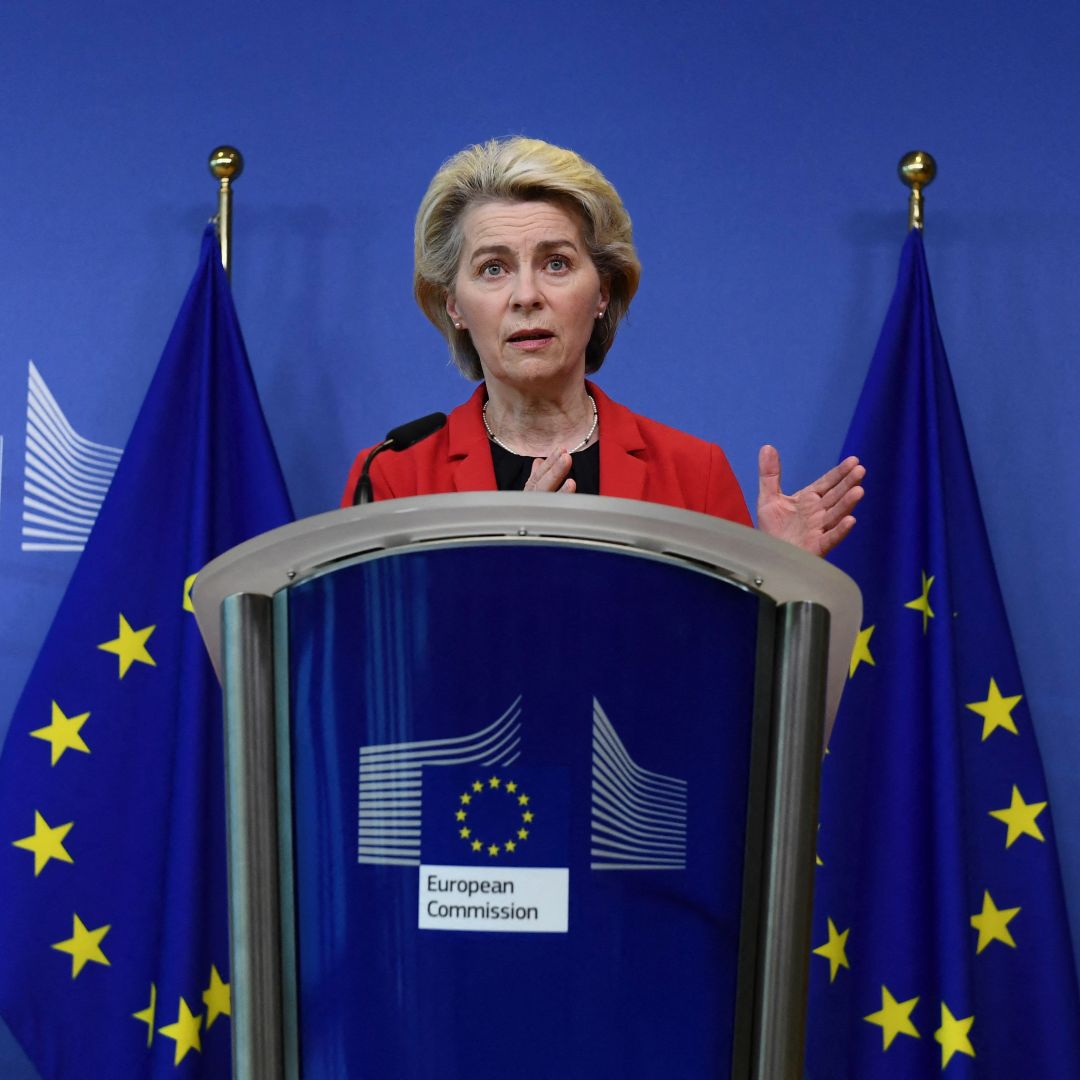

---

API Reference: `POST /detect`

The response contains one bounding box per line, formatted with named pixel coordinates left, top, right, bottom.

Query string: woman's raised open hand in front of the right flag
left=757, top=445, right=866, bottom=555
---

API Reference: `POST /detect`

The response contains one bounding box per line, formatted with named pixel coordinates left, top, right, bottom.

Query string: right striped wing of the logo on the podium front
left=590, top=699, right=687, bottom=870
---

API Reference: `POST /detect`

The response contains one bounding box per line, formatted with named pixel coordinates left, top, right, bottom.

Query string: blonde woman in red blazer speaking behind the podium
left=342, top=138, right=864, bottom=554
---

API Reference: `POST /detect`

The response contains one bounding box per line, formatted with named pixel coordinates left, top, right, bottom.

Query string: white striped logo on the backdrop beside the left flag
left=23, top=361, right=123, bottom=551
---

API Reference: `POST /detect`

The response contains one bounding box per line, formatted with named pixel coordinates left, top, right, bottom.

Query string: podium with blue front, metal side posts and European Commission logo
left=194, top=492, right=861, bottom=1080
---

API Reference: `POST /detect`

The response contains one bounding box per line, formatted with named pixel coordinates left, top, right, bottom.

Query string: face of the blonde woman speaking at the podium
left=446, top=202, right=608, bottom=392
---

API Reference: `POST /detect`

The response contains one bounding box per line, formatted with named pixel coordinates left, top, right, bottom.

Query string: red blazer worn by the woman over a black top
left=341, top=383, right=751, bottom=525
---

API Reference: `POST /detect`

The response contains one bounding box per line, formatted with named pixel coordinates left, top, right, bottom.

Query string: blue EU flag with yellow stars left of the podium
left=0, top=227, right=292, bottom=1080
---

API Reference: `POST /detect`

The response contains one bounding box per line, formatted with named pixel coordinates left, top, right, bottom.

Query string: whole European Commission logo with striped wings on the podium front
left=357, top=698, right=687, bottom=933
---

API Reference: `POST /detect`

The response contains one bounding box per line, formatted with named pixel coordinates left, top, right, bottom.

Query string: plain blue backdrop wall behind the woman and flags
left=0, top=0, right=1080, bottom=1071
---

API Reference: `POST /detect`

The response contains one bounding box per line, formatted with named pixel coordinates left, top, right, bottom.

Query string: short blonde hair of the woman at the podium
left=413, top=136, right=642, bottom=380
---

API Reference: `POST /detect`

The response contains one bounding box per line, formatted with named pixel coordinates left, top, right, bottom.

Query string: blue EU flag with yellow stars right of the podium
left=808, top=230, right=1080, bottom=1080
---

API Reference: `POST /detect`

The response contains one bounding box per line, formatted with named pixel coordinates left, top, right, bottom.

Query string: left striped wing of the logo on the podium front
left=359, top=697, right=522, bottom=866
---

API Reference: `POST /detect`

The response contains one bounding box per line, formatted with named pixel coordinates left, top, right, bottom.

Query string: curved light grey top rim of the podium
left=192, top=491, right=862, bottom=732
